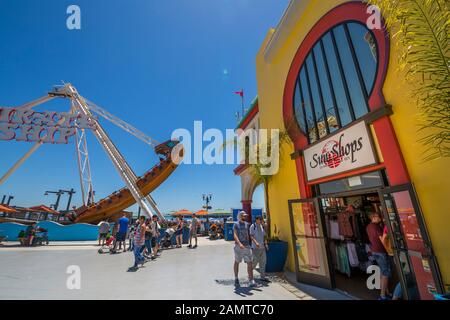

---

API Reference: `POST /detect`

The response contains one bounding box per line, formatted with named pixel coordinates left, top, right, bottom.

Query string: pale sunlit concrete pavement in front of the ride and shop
left=0, top=238, right=314, bottom=300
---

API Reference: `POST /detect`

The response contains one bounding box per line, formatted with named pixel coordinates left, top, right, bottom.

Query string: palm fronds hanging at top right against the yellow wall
left=366, top=0, right=450, bottom=161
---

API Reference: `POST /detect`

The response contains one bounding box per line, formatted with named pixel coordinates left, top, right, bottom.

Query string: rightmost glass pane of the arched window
left=348, top=22, right=378, bottom=94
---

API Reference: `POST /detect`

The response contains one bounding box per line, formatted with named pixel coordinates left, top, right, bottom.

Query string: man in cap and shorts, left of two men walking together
left=233, top=211, right=255, bottom=287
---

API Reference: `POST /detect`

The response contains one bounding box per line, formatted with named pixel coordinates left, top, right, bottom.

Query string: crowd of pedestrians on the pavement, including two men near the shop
left=98, top=211, right=269, bottom=278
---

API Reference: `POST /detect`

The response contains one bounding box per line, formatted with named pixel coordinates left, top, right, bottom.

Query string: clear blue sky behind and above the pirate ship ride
left=0, top=0, right=288, bottom=212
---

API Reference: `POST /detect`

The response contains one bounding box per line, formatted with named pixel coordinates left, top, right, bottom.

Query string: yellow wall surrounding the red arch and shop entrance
left=256, top=0, right=450, bottom=284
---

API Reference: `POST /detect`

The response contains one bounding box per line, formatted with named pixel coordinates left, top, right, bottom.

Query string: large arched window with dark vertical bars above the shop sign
left=293, top=21, right=378, bottom=143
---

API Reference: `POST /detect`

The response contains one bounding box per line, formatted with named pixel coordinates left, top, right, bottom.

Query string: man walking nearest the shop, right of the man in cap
left=250, top=216, right=269, bottom=282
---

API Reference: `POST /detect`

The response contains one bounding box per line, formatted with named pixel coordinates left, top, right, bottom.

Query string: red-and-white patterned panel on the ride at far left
left=0, top=108, right=95, bottom=144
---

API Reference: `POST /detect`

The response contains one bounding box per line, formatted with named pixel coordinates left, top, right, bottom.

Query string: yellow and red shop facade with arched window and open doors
left=246, top=0, right=450, bottom=299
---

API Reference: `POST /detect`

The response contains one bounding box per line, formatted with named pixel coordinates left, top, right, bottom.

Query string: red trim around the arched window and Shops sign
left=283, top=2, right=409, bottom=198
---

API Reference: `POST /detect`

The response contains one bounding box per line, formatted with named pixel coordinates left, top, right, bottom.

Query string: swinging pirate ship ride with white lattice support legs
left=0, top=84, right=183, bottom=223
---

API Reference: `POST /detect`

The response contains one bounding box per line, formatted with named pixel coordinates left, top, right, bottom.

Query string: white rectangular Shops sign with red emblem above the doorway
left=303, top=121, right=377, bottom=181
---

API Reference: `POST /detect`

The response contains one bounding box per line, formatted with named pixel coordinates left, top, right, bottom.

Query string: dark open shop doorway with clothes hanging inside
left=319, top=190, right=399, bottom=300
